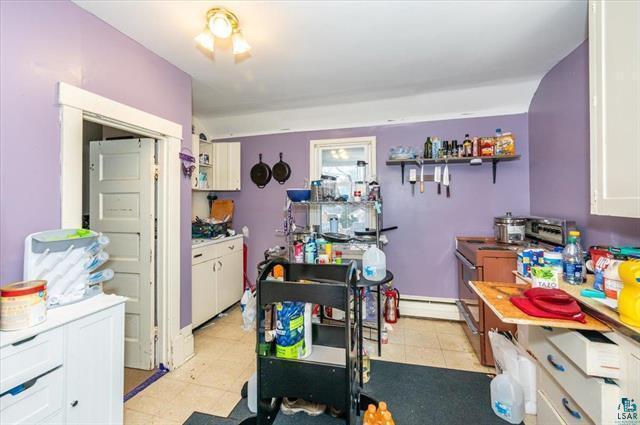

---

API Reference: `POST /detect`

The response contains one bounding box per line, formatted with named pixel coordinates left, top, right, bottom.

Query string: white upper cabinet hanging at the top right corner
left=589, top=0, right=640, bottom=217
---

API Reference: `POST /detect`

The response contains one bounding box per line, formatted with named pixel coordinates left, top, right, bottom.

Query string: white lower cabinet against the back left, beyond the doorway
left=191, top=237, right=244, bottom=328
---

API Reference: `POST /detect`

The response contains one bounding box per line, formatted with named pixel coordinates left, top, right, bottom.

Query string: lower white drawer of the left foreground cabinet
left=0, top=367, right=64, bottom=425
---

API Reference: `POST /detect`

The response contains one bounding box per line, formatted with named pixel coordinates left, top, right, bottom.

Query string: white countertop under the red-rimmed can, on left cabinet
left=0, top=294, right=127, bottom=347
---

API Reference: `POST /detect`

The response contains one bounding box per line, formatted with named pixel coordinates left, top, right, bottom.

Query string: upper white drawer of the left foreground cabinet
left=0, top=328, right=63, bottom=394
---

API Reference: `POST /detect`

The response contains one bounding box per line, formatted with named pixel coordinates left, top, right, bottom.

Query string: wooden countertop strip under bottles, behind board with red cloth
left=513, top=270, right=640, bottom=342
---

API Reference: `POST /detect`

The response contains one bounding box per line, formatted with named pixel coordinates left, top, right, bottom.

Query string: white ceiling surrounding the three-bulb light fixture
left=75, top=0, right=587, bottom=135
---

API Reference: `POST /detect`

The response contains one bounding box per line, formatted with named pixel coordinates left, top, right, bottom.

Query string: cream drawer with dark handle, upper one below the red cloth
left=529, top=327, right=620, bottom=424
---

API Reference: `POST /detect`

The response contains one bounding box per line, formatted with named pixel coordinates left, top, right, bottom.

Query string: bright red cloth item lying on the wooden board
left=510, top=288, right=587, bottom=323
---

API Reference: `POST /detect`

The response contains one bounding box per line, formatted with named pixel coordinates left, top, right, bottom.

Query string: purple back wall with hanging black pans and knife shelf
left=222, top=114, right=529, bottom=298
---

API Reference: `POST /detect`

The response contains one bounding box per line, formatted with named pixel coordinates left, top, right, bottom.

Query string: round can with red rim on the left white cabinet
left=0, top=280, right=47, bottom=331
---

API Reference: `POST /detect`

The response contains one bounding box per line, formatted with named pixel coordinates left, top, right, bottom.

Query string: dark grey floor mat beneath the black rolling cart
left=184, top=361, right=507, bottom=425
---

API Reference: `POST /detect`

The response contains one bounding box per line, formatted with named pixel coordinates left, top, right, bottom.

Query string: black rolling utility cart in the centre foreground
left=242, top=258, right=377, bottom=425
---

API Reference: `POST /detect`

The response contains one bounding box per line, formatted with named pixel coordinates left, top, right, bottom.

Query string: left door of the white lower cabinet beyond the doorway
left=191, top=259, right=218, bottom=327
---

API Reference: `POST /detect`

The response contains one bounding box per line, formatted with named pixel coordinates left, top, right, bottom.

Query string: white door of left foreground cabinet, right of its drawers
left=64, top=304, right=124, bottom=424
